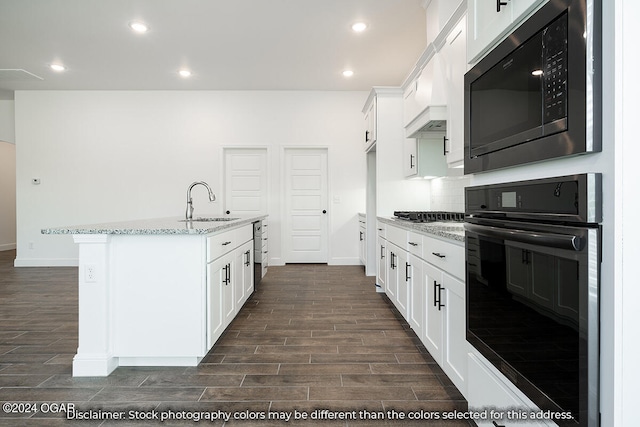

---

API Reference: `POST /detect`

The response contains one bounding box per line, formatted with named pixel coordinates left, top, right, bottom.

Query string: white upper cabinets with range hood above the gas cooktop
left=403, top=1, right=468, bottom=177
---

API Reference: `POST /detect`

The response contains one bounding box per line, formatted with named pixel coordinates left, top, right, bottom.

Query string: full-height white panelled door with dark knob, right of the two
left=283, top=148, right=329, bottom=263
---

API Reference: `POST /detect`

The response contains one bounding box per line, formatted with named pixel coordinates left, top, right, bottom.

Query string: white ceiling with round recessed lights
left=0, top=0, right=427, bottom=97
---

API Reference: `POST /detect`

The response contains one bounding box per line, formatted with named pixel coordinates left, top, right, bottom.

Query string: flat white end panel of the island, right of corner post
left=111, top=235, right=207, bottom=366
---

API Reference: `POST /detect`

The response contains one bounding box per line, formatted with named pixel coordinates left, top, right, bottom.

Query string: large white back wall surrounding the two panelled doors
left=15, top=91, right=367, bottom=266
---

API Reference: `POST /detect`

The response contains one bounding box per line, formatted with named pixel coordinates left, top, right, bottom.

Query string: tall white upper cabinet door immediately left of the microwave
left=440, top=17, right=468, bottom=164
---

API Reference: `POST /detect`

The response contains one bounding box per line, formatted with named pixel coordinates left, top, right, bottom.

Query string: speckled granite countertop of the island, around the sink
left=41, top=215, right=267, bottom=235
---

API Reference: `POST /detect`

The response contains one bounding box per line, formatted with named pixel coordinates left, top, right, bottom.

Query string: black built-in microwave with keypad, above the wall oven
left=464, top=0, right=601, bottom=173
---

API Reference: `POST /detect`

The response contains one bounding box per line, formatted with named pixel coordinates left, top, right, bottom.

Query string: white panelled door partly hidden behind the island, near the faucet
left=224, top=148, right=268, bottom=216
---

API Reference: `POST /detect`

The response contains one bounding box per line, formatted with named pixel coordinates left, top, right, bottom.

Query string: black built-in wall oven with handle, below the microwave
left=465, top=174, right=602, bottom=426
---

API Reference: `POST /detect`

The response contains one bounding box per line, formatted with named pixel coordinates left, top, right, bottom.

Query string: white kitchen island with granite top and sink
left=42, top=215, right=266, bottom=376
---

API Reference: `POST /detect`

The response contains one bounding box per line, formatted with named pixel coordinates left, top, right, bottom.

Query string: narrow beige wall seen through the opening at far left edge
left=0, top=141, right=16, bottom=251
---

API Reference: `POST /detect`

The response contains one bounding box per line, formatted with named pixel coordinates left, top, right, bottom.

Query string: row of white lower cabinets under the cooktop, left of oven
left=378, top=224, right=469, bottom=396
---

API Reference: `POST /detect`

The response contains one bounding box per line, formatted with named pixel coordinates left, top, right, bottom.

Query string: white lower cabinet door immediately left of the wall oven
left=442, top=273, right=469, bottom=395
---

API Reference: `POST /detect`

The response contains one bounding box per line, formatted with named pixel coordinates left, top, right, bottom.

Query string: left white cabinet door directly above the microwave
left=467, top=0, right=513, bottom=63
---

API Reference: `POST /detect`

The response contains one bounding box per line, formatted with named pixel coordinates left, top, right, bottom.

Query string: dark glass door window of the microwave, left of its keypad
left=470, top=33, right=544, bottom=157
